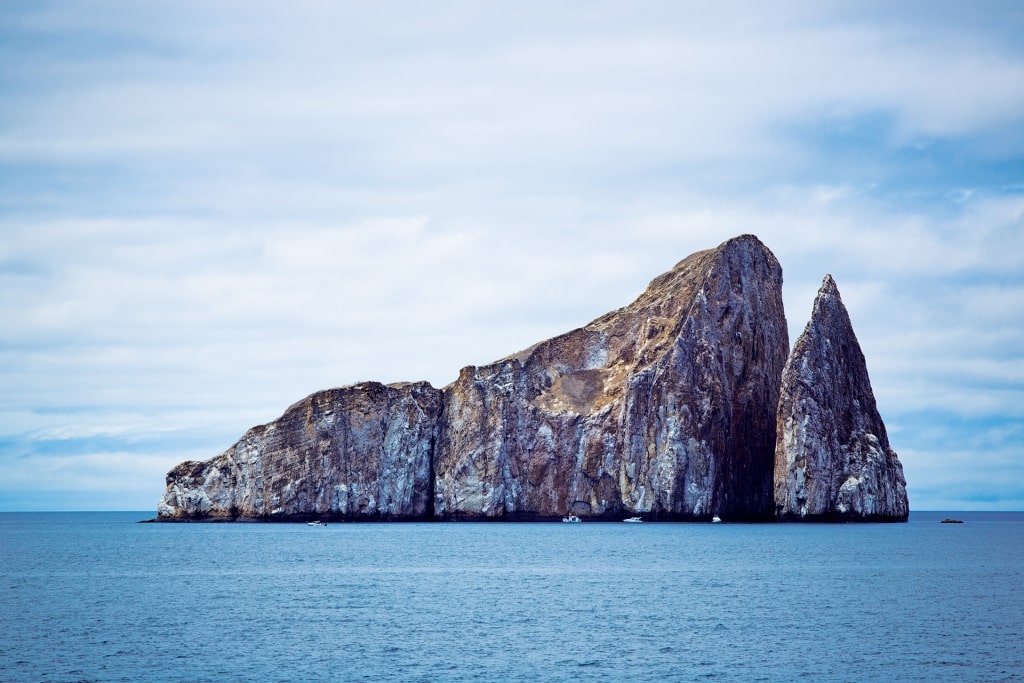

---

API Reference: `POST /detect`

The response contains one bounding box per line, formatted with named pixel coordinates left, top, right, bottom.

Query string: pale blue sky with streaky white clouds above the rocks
left=0, top=0, right=1024, bottom=511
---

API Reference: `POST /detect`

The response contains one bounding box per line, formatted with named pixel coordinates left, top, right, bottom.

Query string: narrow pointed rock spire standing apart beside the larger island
left=775, top=275, right=909, bottom=521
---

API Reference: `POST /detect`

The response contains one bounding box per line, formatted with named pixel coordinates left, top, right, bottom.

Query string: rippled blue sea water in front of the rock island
left=0, top=513, right=1024, bottom=682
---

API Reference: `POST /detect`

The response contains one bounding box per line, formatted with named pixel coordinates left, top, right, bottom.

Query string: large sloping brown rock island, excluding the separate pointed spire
left=158, top=236, right=905, bottom=520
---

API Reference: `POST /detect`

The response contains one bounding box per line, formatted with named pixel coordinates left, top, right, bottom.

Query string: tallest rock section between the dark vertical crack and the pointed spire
left=434, top=236, right=788, bottom=519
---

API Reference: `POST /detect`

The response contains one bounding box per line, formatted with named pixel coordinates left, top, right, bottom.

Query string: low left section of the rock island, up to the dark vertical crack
left=158, top=382, right=441, bottom=520
